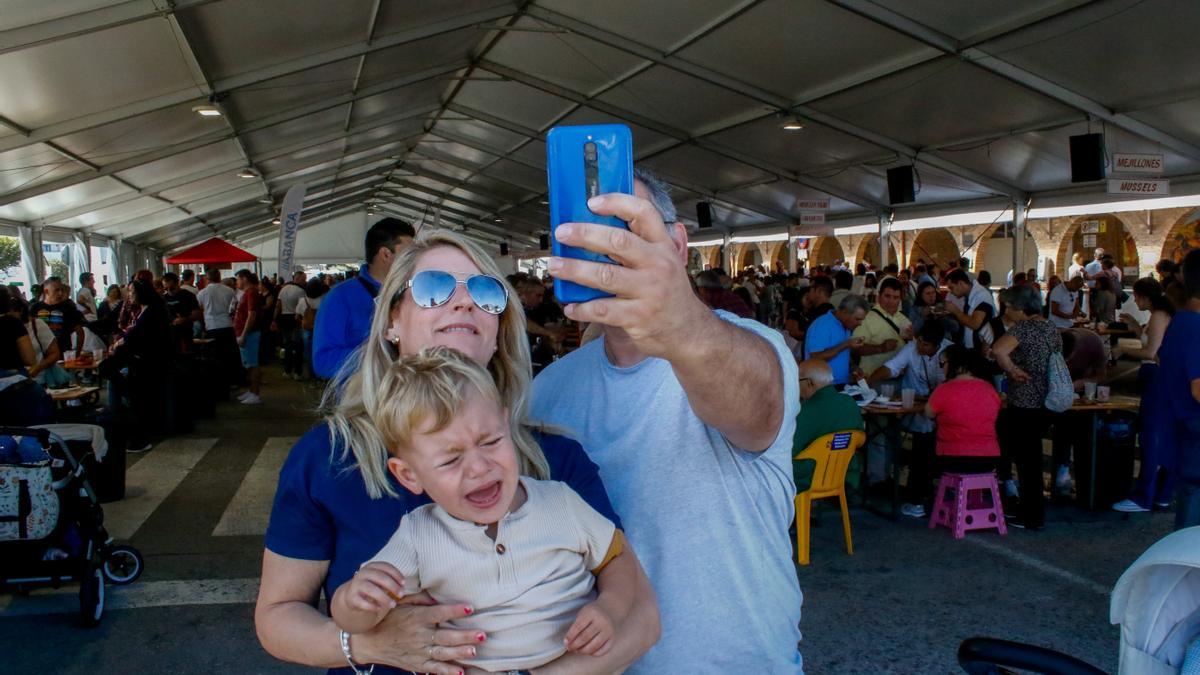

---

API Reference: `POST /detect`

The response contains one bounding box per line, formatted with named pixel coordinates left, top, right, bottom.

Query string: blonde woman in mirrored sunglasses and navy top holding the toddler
left=254, top=231, right=659, bottom=675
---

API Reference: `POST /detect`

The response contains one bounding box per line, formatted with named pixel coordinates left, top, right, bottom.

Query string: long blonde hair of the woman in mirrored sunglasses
left=320, top=229, right=550, bottom=498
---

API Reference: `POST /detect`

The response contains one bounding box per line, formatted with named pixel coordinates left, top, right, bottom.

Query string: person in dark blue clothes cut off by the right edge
left=1154, top=250, right=1200, bottom=530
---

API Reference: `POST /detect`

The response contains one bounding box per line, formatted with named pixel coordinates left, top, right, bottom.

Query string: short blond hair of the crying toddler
left=371, top=347, right=504, bottom=454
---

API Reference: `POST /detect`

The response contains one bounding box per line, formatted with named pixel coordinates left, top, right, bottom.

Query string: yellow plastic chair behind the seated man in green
left=796, top=430, right=866, bottom=565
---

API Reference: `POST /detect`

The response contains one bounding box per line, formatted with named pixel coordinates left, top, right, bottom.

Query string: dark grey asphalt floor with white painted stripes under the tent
left=0, top=368, right=1172, bottom=675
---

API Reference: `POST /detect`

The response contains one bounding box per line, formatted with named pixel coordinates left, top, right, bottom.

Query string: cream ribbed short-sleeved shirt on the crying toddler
left=368, top=477, right=616, bottom=671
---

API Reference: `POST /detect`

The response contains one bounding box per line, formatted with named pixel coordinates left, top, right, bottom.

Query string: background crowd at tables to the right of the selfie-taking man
left=694, top=243, right=1200, bottom=530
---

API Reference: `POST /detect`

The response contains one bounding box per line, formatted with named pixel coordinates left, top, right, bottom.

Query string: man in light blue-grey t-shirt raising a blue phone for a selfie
left=530, top=171, right=803, bottom=673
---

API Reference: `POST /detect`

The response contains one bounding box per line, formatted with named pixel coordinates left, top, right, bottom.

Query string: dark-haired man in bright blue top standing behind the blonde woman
left=312, top=217, right=416, bottom=380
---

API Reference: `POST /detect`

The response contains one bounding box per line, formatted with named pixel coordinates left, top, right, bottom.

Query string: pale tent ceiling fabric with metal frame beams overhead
left=0, top=0, right=1200, bottom=255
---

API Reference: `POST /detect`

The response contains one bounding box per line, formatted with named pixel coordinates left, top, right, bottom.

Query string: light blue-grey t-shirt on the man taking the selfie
left=530, top=312, right=803, bottom=674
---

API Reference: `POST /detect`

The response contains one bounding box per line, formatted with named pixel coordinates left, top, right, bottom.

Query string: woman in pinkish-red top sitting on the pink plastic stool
left=925, top=345, right=1000, bottom=477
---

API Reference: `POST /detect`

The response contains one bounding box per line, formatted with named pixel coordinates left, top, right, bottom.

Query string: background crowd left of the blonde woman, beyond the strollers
left=0, top=260, right=353, bottom=444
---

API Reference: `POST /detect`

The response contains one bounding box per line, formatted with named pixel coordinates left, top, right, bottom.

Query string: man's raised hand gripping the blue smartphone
left=550, top=195, right=713, bottom=357
